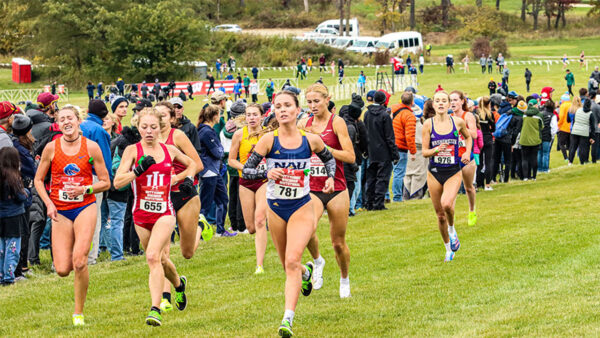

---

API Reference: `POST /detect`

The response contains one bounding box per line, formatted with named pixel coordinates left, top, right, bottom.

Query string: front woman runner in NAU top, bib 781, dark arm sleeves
left=242, top=90, right=338, bottom=337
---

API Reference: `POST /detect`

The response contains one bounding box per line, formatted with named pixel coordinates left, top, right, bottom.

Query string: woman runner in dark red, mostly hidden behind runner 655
left=155, top=101, right=203, bottom=311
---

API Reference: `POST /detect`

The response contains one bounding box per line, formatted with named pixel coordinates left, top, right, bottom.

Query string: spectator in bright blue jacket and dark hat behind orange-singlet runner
left=80, top=100, right=113, bottom=265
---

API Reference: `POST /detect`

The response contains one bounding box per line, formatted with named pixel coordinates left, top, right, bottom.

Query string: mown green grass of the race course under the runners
left=0, top=152, right=600, bottom=337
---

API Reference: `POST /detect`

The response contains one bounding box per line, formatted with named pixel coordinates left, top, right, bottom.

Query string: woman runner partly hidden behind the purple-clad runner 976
left=450, top=90, right=477, bottom=226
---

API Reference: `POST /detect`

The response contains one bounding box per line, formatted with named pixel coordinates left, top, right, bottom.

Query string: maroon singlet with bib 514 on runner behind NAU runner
left=306, top=114, right=346, bottom=192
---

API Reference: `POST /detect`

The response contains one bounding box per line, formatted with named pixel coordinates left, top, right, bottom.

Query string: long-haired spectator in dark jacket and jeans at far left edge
left=0, top=147, right=30, bottom=286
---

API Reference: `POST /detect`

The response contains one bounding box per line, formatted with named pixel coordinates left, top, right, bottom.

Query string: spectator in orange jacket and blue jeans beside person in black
left=392, top=91, right=417, bottom=202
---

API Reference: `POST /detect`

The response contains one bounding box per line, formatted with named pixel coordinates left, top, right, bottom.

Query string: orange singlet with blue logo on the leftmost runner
left=50, top=136, right=96, bottom=210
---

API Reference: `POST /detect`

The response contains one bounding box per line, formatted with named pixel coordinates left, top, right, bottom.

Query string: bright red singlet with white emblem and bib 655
left=131, top=143, right=175, bottom=231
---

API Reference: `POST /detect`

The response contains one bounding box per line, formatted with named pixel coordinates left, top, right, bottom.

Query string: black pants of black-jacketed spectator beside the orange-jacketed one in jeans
left=366, top=161, right=392, bottom=210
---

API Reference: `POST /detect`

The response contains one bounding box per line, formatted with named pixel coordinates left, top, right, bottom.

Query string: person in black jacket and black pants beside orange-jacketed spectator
left=364, top=91, right=399, bottom=210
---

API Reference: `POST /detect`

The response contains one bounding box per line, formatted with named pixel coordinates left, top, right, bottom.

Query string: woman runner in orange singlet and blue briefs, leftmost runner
left=34, top=107, right=110, bottom=326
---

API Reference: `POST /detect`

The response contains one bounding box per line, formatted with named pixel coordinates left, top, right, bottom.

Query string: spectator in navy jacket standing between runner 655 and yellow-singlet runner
left=198, top=104, right=237, bottom=237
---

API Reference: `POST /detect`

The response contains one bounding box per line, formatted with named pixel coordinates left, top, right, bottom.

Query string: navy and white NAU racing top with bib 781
left=266, top=130, right=312, bottom=200
